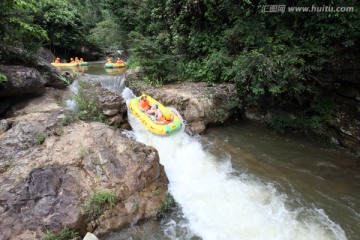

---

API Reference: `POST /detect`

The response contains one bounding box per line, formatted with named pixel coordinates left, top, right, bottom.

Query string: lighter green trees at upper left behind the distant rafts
left=0, top=0, right=119, bottom=61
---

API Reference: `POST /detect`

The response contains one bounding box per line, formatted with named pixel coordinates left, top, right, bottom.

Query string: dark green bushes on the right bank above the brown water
left=109, top=0, right=360, bottom=136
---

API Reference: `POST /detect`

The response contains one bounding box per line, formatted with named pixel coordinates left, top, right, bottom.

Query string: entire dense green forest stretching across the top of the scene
left=0, top=0, right=360, bottom=140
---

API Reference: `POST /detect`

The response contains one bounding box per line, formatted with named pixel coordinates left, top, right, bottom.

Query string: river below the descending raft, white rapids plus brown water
left=66, top=65, right=360, bottom=240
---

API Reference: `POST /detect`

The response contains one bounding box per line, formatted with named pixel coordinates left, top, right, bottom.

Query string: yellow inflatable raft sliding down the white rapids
left=129, top=94, right=182, bottom=135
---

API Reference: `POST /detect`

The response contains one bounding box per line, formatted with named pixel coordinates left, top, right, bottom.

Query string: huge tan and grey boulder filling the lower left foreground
left=0, top=84, right=168, bottom=240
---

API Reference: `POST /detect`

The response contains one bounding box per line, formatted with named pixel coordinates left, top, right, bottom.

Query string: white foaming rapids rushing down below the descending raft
left=129, top=105, right=347, bottom=240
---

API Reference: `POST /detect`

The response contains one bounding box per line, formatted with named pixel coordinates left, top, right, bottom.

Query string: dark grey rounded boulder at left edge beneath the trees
left=0, top=65, right=46, bottom=98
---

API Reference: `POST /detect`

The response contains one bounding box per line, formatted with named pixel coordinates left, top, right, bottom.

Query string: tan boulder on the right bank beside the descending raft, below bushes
left=126, top=76, right=238, bottom=133
